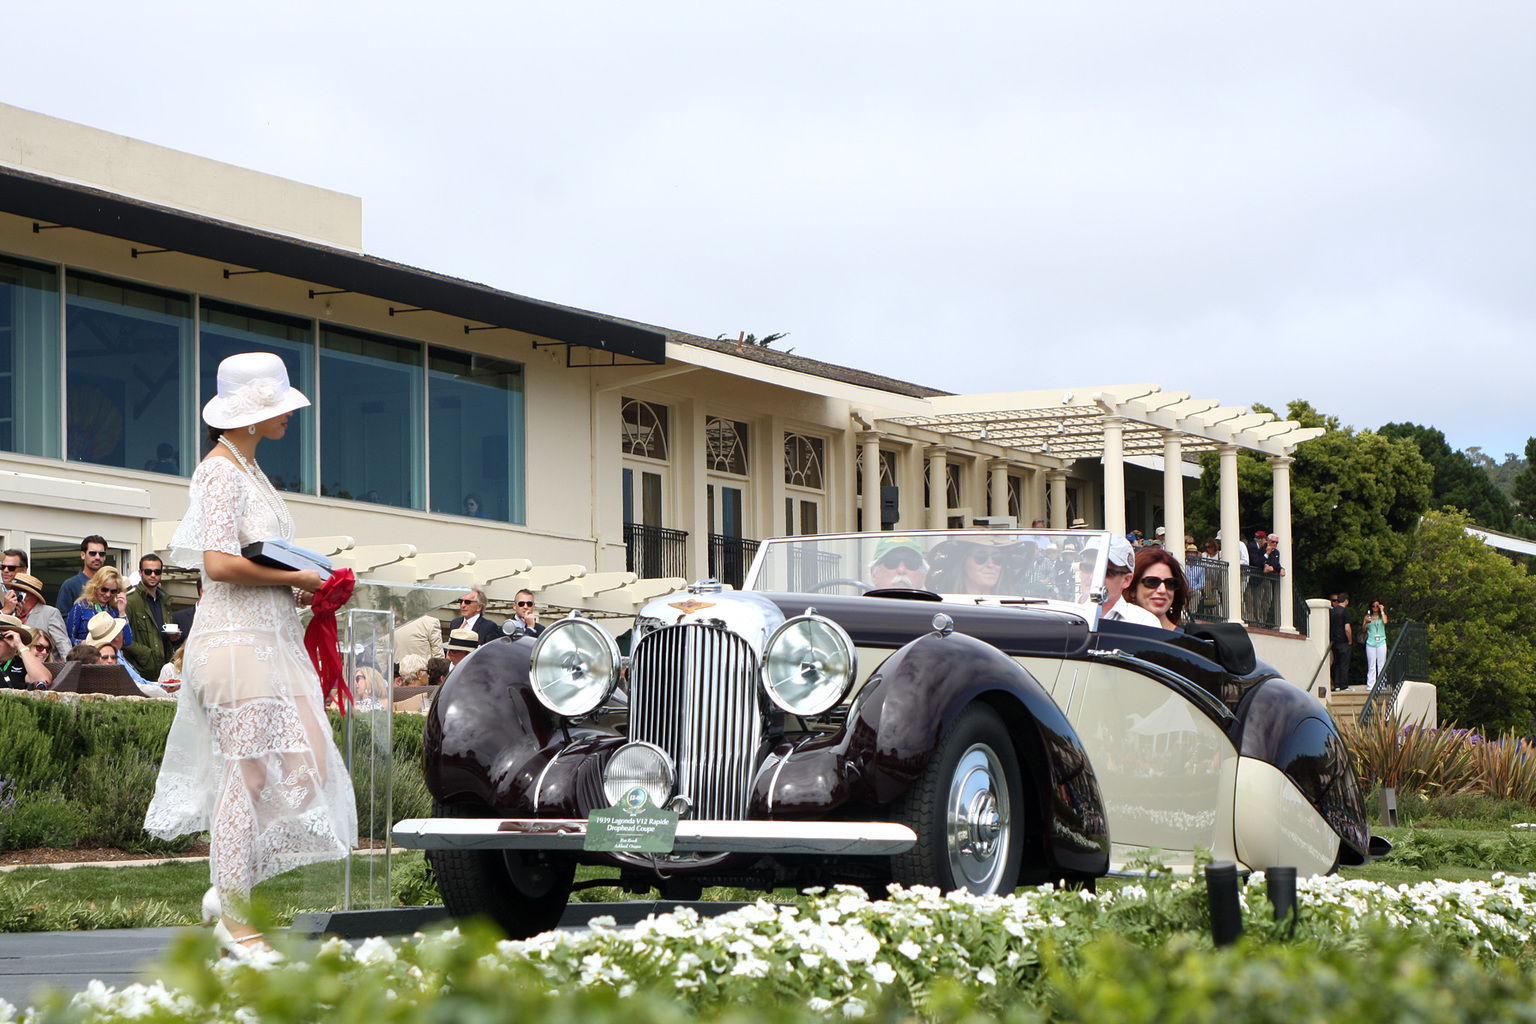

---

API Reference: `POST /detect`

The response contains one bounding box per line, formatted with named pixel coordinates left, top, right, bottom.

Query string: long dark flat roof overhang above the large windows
left=0, top=167, right=667, bottom=364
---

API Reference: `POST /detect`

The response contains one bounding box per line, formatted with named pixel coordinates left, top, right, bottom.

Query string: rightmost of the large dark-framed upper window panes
left=427, top=347, right=524, bottom=522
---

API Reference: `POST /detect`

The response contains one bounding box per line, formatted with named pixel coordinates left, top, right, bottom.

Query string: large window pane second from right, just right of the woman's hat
left=319, top=329, right=425, bottom=508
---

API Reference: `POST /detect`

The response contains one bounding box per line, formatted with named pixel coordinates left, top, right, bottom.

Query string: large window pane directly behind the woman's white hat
left=197, top=299, right=316, bottom=494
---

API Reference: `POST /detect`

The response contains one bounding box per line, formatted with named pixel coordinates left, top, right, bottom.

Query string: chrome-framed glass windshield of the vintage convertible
left=745, top=530, right=1109, bottom=603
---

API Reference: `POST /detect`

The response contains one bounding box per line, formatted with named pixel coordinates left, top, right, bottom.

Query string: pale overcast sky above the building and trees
left=0, top=0, right=1536, bottom=459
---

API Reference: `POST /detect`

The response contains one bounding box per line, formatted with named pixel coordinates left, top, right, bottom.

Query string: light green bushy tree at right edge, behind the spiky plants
left=1387, top=508, right=1536, bottom=732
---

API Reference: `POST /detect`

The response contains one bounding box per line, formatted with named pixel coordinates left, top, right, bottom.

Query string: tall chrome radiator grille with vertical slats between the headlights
left=630, top=625, right=763, bottom=820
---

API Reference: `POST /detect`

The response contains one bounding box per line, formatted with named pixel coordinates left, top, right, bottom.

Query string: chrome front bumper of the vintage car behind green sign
left=392, top=818, right=917, bottom=857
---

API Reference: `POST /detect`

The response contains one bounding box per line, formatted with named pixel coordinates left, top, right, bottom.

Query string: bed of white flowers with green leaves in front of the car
left=18, top=875, right=1536, bottom=1024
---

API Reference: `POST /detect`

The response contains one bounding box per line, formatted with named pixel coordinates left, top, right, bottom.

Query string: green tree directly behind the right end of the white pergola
left=1189, top=399, right=1433, bottom=597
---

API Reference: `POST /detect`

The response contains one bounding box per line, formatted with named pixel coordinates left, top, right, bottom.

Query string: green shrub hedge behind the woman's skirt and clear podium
left=0, top=692, right=432, bottom=854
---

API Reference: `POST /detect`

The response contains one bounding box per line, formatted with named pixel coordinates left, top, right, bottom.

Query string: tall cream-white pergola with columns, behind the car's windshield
left=878, top=384, right=1324, bottom=631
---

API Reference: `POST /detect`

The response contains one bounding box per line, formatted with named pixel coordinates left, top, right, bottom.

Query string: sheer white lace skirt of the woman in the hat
left=144, top=583, right=358, bottom=906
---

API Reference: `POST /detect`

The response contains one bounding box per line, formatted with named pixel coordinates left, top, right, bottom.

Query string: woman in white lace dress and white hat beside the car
left=144, top=352, right=358, bottom=953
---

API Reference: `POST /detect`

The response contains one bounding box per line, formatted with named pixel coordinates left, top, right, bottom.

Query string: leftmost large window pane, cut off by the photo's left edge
left=0, top=259, right=63, bottom=459
